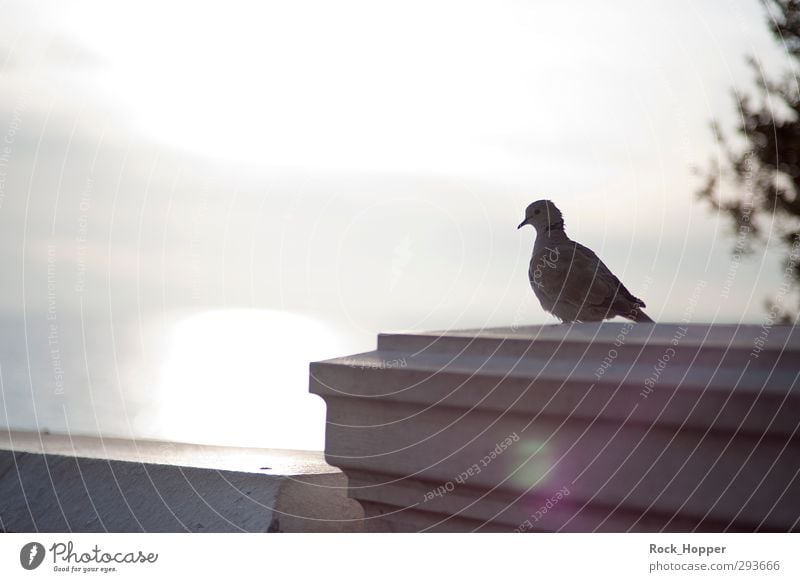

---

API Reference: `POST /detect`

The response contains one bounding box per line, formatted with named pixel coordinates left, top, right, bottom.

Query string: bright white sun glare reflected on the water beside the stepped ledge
left=145, top=309, right=346, bottom=450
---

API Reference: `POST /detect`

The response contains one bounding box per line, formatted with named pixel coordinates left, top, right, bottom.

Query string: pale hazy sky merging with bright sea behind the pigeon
left=0, top=0, right=787, bottom=449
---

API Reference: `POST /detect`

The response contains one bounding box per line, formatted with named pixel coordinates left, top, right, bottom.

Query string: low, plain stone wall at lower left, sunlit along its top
left=0, top=431, right=363, bottom=532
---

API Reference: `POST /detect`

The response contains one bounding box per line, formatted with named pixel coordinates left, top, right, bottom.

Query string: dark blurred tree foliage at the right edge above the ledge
left=697, top=0, right=800, bottom=323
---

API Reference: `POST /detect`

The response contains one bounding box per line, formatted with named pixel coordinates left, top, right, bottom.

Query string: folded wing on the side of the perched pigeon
left=541, top=241, right=620, bottom=309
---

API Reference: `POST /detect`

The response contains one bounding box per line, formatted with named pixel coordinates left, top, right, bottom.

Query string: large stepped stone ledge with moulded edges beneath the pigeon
left=310, top=323, right=800, bottom=532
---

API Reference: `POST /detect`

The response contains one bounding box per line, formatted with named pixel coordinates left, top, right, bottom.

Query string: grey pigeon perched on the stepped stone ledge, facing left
left=517, top=200, right=653, bottom=323
